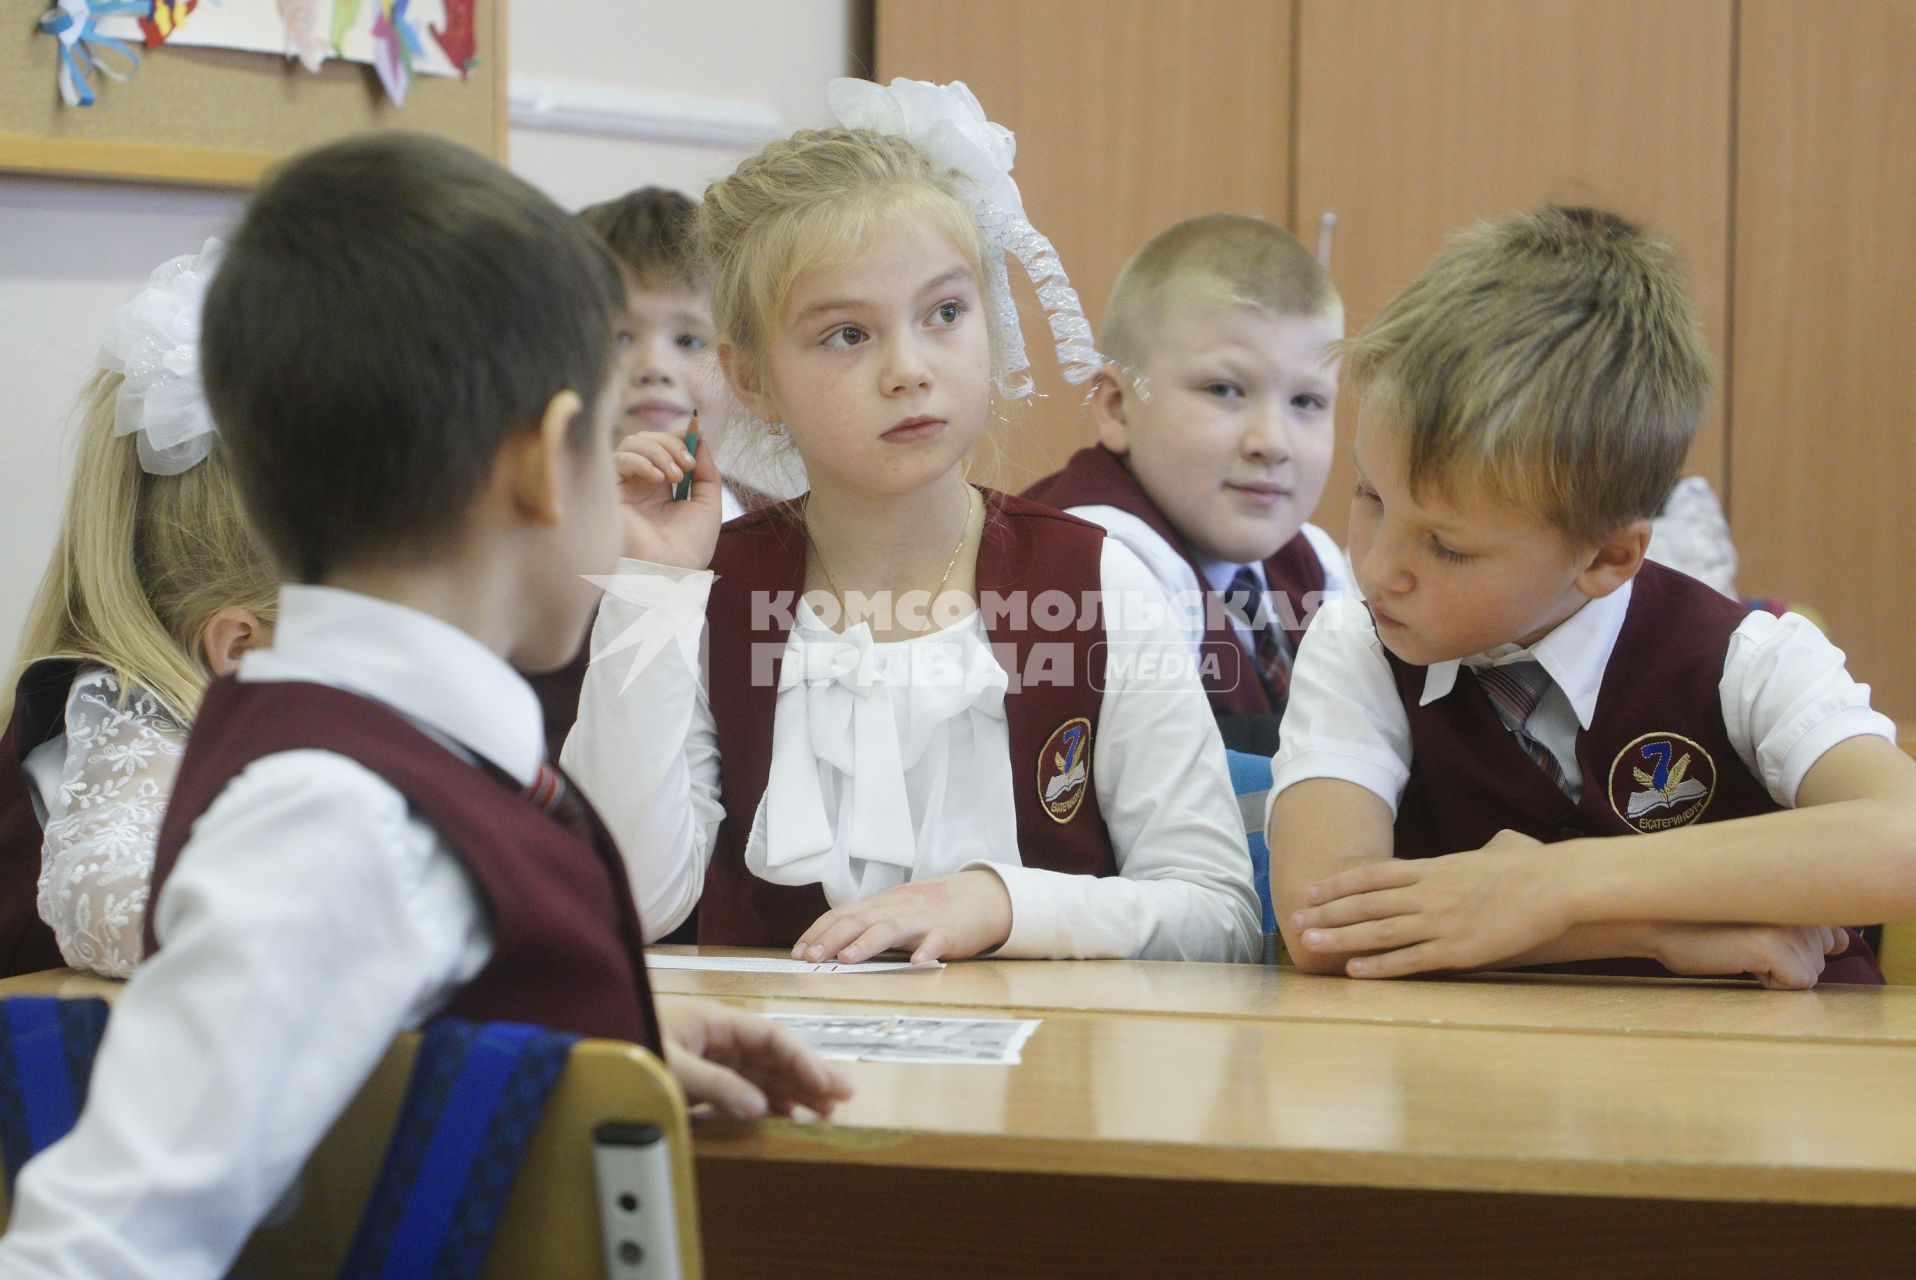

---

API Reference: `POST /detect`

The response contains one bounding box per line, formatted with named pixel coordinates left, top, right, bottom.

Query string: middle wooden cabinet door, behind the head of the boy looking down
left=1295, top=0, right=1732, bottom=540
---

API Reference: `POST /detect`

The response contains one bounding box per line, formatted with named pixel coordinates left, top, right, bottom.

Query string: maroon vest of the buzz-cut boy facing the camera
left=1025, top=445, right=1324, bottom=717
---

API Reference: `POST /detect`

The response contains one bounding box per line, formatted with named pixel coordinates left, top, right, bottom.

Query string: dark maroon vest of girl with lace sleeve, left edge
left=0, top=657, right=80, bottom=977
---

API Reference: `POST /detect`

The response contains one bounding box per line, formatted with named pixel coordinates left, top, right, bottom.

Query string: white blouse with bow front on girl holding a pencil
left=563, top=538, right=1261, bottom=960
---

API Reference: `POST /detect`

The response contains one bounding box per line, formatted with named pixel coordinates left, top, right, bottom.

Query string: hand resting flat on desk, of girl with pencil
left=791, top=870, right=1012, bottom=964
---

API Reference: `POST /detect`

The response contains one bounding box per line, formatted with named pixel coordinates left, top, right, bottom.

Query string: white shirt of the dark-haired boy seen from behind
left=0, top=586, right=544, bottom=1280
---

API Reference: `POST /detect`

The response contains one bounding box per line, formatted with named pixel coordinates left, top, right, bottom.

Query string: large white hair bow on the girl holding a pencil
left=826, top=79, right=1104, bottom=397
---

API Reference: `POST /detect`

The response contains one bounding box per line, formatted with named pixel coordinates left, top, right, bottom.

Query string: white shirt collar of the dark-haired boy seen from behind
left=240, top=584, right=546, bottom=784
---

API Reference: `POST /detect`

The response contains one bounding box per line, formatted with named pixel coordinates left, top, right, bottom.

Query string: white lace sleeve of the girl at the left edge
left=40, top=667, right=186, bottom=977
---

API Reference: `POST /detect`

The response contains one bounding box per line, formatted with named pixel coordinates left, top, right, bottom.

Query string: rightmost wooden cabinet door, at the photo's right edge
left=1730, top=0, right=1916, bottom=722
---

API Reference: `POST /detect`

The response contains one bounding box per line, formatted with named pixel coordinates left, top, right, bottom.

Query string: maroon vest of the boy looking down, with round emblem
left=1385, top=561, right=1883, bottom=983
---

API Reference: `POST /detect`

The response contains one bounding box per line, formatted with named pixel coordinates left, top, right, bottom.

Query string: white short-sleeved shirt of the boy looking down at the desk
left=1270, top=583, right=1897, bottom=814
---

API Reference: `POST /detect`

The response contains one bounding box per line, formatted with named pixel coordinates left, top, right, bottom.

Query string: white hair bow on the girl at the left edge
left=100, top=240, right=226, bottom=475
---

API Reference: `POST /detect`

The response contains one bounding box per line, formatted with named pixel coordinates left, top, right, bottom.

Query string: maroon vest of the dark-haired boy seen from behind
left=146, top=680, right=661, bottom=1052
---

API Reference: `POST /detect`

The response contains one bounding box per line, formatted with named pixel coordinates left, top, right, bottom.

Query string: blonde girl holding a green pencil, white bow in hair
left=565, top=80, right=1259, bottom=962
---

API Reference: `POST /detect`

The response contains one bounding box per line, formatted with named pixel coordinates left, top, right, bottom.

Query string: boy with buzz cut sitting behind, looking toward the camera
left=1025, top=213, right=1349, bottom=755
